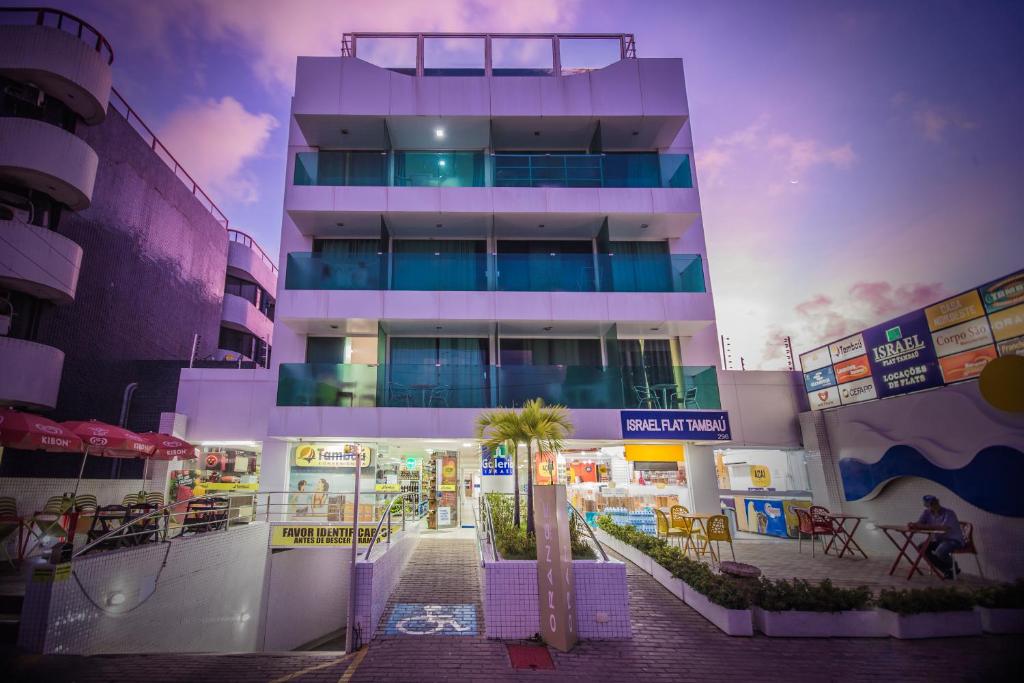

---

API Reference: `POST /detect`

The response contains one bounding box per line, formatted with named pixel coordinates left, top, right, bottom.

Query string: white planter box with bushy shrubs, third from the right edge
left=754, top=579, right=889, bottom=638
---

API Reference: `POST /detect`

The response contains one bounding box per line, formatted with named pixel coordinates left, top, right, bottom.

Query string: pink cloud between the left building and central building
left=159, top=97, right=278, bottom=204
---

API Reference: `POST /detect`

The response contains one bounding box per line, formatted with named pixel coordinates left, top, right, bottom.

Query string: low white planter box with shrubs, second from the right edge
left=878, top=588, right=981, bottom=638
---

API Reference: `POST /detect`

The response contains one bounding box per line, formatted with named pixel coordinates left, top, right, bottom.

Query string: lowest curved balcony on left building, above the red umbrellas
left=0, top=337, right=63, bottom=408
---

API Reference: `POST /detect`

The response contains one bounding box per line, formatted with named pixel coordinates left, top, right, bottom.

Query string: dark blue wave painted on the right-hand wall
left=839, top=444, right=1024, bottom=517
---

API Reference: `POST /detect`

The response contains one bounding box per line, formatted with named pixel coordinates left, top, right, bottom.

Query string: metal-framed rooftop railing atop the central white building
left=341, top=33, right=637, bottom=76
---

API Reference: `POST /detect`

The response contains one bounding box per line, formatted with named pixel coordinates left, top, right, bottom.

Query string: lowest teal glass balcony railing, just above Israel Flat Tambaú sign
left=278, top=364, right=721, bottom=410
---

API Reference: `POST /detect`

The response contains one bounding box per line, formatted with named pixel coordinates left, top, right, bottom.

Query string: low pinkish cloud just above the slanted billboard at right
left=761, top=281, right=945, bottom=365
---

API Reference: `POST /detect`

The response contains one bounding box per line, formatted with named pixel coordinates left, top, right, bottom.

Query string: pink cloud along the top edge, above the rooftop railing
left=104, top=0, right=580, bottom=90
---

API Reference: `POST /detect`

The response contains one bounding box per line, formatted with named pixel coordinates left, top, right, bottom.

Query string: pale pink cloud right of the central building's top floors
left=696, top=117, right=857, bottom=194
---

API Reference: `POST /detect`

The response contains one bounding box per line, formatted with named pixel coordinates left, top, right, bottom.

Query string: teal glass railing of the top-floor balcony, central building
left=293, top=150, right=693, bottom=188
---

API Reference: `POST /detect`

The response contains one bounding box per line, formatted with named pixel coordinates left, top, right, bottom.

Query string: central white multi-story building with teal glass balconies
left=169, top=34, right=799, bottom=521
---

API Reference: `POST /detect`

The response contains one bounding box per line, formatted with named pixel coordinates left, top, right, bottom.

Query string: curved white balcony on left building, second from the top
left=0, top=118, right=99, bottom=211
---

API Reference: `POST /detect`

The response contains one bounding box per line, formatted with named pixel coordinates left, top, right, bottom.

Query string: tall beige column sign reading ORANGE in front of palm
left=534, top=484, right=578, bottom=652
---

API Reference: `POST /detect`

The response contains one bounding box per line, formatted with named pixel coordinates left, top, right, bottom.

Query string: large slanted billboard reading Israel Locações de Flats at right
left=800, top=270, right=1024, bottom=411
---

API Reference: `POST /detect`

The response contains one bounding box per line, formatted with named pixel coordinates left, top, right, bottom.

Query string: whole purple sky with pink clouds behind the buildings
left=44, top=0, right=1024, bottom=369
